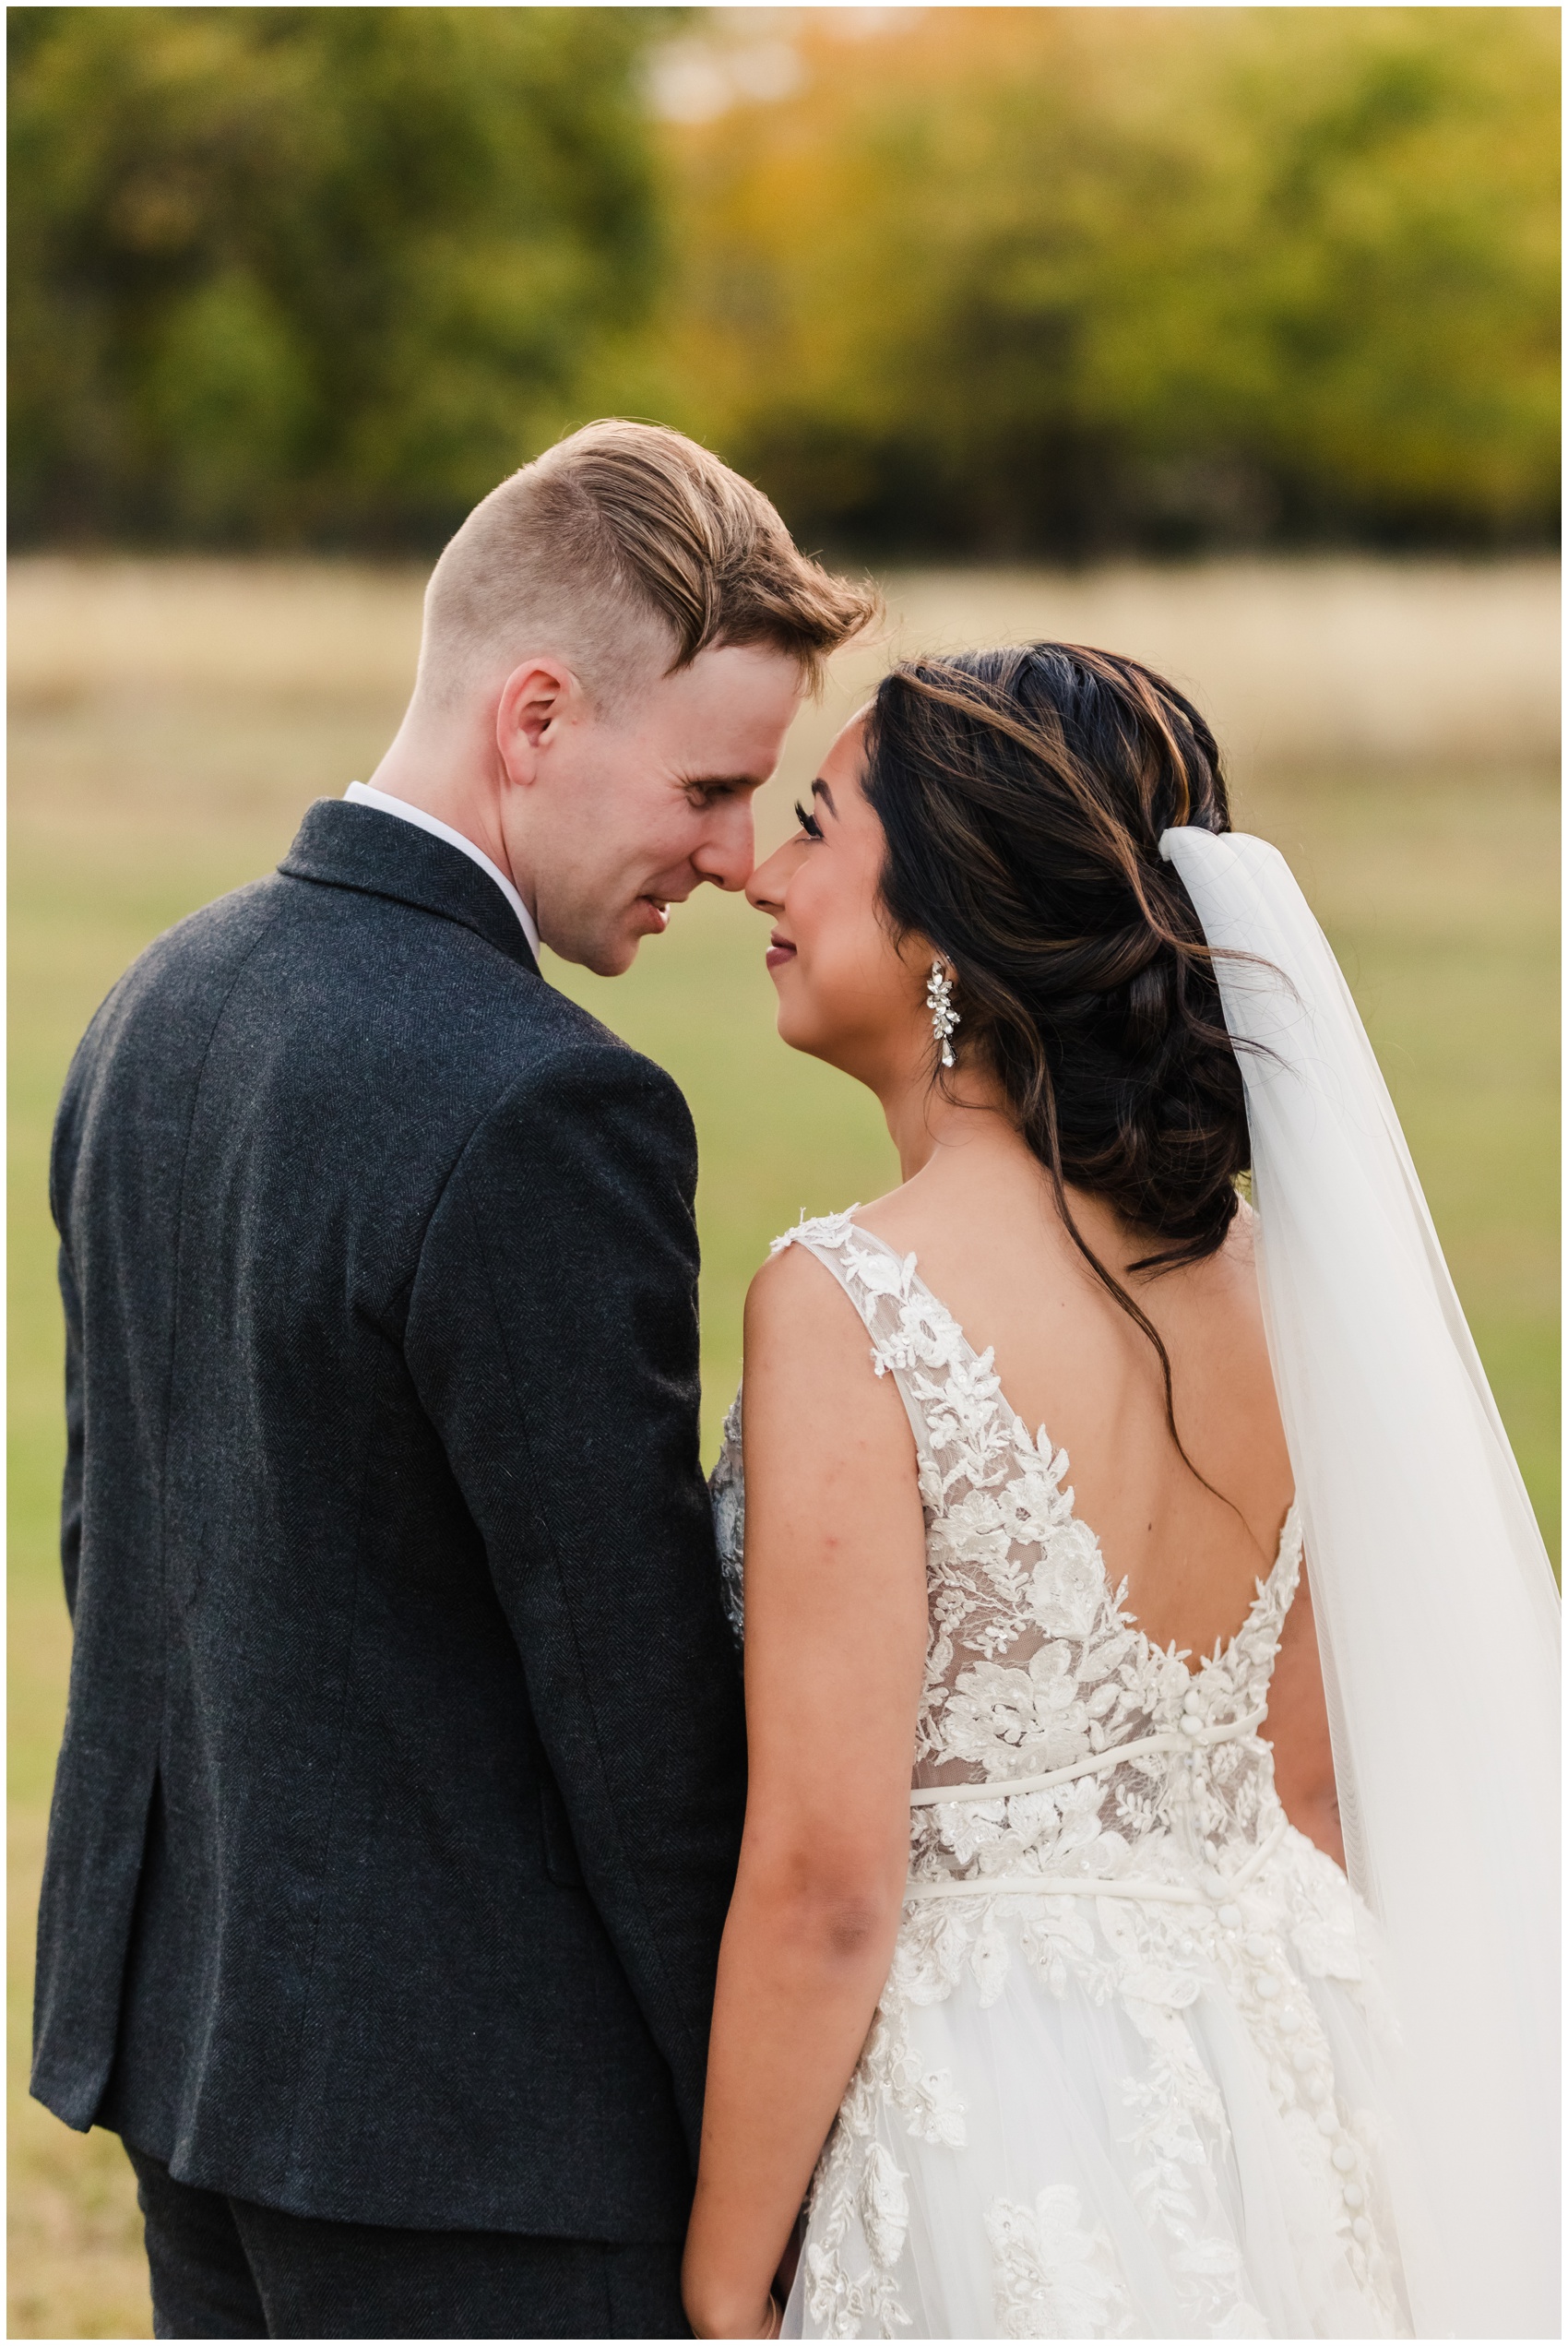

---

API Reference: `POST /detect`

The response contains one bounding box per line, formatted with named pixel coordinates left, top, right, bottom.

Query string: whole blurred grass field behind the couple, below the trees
left=9, top=563, right=1559, bottom=2337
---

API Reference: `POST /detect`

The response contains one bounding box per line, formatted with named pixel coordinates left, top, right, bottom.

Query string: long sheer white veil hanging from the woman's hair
left=1160, top=828, right=1561, bottom=2339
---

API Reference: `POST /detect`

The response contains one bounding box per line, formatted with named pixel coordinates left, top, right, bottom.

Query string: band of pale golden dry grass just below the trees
left=9, top=558, right=1561, bottom=774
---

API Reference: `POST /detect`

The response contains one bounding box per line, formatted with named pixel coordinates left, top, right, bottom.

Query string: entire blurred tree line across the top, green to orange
left=9, top=7, right=1559, bottom=556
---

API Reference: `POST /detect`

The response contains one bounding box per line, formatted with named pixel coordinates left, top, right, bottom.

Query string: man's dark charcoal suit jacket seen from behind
left=33, top=800, right=743, bottom=2241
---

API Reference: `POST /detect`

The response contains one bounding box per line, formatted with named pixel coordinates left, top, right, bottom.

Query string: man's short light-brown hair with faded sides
left=420, top=420, right=879, bottom=706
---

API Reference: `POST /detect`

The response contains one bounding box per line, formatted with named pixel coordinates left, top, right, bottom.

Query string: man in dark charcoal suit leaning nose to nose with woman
left=33, top=424, right=867, bottom=2337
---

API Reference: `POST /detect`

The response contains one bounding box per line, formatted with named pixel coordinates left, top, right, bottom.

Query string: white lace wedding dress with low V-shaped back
left=712, top=1213, right=1408, bottom=2339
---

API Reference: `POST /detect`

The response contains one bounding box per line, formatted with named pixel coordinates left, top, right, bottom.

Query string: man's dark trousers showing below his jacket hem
left=126, top=2142, right=692, bottom=2339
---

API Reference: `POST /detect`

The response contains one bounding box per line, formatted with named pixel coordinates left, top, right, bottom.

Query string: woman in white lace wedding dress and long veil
left=687, top=645, right=1556, bottom=2339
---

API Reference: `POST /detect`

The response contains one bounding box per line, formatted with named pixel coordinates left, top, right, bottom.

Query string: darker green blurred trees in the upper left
left=9, top=7, right=663, bottom=542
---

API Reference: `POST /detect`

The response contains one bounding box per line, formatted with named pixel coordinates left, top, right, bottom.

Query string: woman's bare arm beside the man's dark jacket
left=684, top=1248, right=926, bottom=2339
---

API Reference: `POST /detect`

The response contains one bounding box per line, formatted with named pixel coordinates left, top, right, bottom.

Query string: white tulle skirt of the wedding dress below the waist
left=785, top=1832, right=1408, bottom=2339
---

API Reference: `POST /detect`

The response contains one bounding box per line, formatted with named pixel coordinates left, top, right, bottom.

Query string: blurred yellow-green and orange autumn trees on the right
left=656, top=7, right=1559, bottom=554
